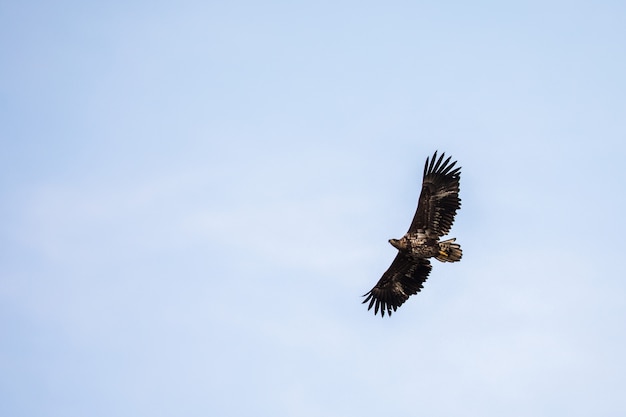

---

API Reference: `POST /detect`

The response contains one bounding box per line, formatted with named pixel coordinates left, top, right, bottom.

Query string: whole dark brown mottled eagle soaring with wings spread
left=363, top=151, right=463, bottom=317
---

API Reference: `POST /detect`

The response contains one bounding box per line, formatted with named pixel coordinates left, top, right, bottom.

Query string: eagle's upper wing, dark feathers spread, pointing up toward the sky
left=409, top=151, right=461, bottom=237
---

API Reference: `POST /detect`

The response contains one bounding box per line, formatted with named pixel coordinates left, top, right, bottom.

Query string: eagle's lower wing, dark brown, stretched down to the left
left=363, top=252, right=432, bottom=317
